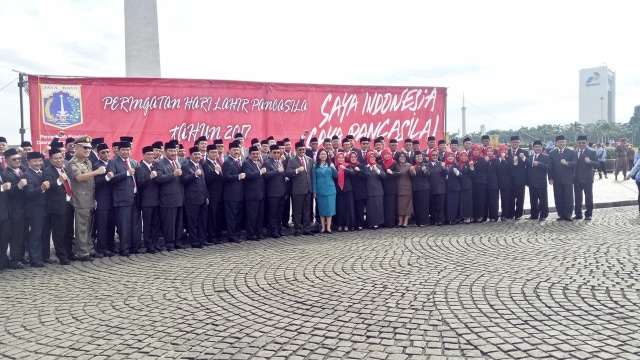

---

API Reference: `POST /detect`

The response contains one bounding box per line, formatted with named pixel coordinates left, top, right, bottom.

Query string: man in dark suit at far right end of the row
left=573, top=135, right=599, bottom=220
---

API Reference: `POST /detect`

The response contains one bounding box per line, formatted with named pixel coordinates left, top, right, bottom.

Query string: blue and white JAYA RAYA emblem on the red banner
left=40, top=84, right=82, bottom=129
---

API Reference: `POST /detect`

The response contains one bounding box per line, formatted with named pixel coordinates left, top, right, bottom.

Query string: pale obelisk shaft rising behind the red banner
left=124, top=0, right=161, bottom=77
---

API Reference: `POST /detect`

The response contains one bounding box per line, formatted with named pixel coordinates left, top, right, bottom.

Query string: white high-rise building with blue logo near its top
left=578, top=65, right=616, bottom=124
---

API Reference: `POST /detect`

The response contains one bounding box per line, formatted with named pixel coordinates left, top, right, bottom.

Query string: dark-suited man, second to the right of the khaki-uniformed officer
left=105, top=141, right=140, bottom=256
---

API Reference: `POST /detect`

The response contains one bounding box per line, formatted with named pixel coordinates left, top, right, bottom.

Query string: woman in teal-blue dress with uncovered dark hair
left=312, top=149, right=338, bottom=234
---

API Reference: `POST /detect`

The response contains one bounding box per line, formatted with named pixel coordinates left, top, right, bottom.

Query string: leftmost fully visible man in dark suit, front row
left=2, top=149, right=27, bottom=269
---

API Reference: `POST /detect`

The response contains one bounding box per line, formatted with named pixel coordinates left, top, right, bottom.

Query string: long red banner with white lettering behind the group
left=29, top=75, right=446, bottom=158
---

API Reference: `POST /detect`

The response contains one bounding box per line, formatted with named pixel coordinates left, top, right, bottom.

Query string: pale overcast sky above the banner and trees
left=0, top=0, right=640, bottom=144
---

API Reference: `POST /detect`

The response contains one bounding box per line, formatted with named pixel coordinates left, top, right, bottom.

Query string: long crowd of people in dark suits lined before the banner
left=0, top=132, right=640, bottom=270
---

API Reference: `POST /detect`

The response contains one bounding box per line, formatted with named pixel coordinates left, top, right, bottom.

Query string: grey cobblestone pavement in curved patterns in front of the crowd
left=0, top=207, right=640, bottom=359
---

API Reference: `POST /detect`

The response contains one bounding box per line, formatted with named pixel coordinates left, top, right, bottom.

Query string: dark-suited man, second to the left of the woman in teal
left=263, top=145, right=289, bottom=239
